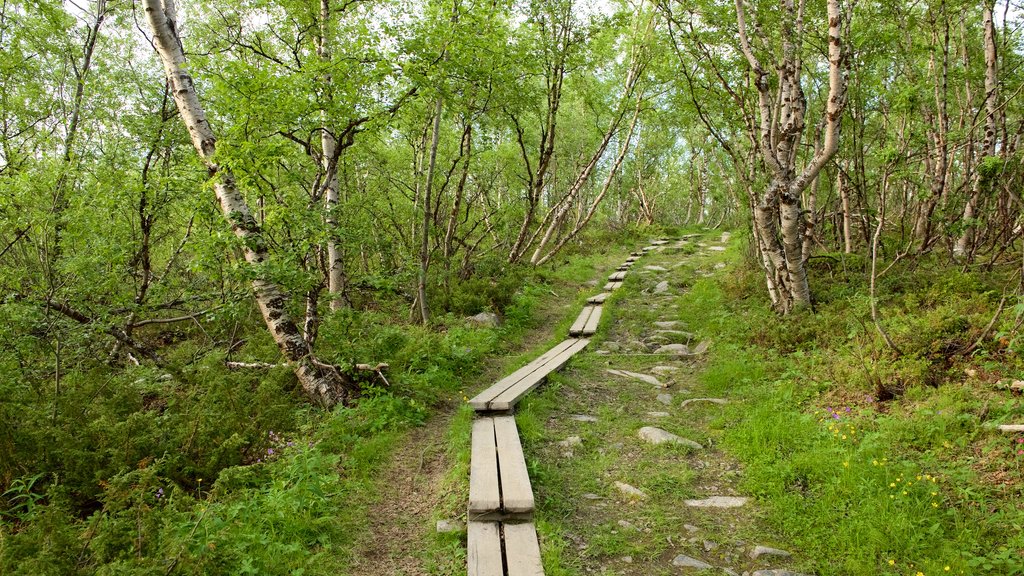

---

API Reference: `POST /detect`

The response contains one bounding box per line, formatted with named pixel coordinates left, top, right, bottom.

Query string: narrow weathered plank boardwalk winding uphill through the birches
left=466, top=240, right=669, bottom=576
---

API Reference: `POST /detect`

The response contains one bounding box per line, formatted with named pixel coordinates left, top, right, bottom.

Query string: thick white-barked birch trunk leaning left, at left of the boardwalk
left=143, top=0, right=352, bottom=407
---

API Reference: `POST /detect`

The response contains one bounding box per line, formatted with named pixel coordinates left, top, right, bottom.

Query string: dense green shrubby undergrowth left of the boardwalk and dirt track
left=0, top=227, right=629, bottom=576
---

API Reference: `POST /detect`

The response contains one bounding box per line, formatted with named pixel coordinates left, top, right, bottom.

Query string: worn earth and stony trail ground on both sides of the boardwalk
left=353, top=233, right=800, bottom=576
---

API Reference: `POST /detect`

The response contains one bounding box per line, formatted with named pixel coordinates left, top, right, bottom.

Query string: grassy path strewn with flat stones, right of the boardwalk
left=526, top=233, right=806, bottom=576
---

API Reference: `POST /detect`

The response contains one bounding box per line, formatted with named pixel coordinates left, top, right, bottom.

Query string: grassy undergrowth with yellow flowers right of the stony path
left=679, top=230, right=1024, bottom=576
